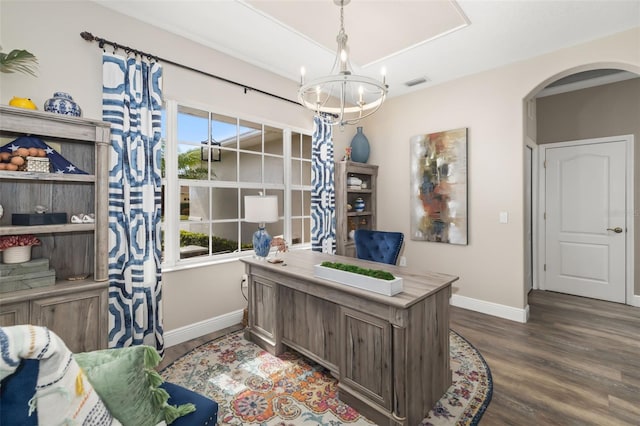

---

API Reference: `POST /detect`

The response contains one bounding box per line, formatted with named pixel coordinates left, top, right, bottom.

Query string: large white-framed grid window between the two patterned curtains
left=162, top=101, right=311, bottom=265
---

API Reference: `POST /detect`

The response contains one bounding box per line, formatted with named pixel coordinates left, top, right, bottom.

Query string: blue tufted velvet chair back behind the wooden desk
left=353, top=229, right=404, bottom=265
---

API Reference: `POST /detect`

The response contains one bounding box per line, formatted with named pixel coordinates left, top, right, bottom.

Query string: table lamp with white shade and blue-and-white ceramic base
left=244, top=195, right=278, bottom=259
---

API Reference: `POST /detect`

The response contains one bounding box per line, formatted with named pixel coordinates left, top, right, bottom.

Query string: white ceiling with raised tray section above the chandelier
left=93, top=0, right=640, bottom=99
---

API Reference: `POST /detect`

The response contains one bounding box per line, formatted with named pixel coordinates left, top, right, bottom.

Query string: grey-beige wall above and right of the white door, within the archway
left=537, top=78, right=640, bottom=294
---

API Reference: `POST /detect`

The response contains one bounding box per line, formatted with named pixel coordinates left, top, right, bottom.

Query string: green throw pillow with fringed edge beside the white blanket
left=74, top=345, right=195, bottom=426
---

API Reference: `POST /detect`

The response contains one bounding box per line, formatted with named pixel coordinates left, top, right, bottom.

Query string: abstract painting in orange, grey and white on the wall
left=411, top=128, right=467, bottom=245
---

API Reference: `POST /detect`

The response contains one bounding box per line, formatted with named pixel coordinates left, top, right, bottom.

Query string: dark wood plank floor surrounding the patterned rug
left=160, top=291, right=640, bottom=426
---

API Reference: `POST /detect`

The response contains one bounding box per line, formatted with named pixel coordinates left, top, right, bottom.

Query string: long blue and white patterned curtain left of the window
left=102, top=53, right=164, bottom=353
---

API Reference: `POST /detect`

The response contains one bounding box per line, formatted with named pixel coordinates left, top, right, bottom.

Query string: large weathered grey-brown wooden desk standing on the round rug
left=242, top=251, right=458, bottom=426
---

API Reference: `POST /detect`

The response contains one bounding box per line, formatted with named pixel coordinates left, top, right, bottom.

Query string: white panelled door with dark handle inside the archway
left=545, top=139, right=626, bottom=303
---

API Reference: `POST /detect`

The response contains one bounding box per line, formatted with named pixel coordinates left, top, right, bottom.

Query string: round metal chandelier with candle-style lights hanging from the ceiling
left=298, top=0, right=389, bottom=126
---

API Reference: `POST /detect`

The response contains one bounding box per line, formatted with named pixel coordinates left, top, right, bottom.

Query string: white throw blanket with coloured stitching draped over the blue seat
left=0, top=325, right=121, bottom=426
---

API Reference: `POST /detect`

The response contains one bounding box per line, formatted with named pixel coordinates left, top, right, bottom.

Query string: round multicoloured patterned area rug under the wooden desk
left=161, top=331, right=493, bottom=426
